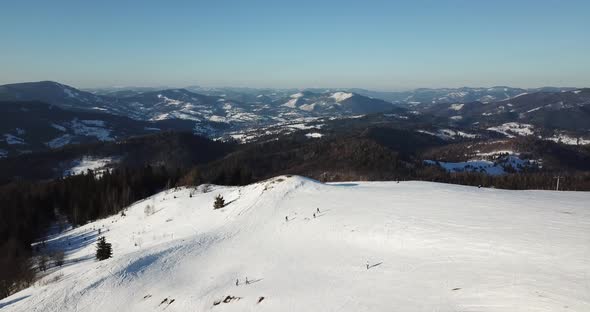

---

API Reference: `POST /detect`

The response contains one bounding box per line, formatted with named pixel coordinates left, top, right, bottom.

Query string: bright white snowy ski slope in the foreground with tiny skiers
left=0, top=176, right=590, bottom=312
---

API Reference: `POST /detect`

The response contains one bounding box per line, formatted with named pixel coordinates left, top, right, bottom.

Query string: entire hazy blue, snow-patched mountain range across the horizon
left=0, top=81, right=590, bottom=156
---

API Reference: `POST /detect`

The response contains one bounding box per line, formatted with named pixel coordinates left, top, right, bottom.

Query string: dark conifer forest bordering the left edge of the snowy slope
left=0, top=165, right=181, bottom=298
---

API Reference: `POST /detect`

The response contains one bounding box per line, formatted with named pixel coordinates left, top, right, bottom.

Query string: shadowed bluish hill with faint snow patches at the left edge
left=0, top=101, right=199, bottom=157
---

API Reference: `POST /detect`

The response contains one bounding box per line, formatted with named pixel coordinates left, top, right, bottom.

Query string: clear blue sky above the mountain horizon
left=0, top=0, right=590, bottom=90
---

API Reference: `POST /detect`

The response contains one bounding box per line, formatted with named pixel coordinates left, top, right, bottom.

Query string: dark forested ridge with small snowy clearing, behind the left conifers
left=0, top=131, right=236, bottom=185
